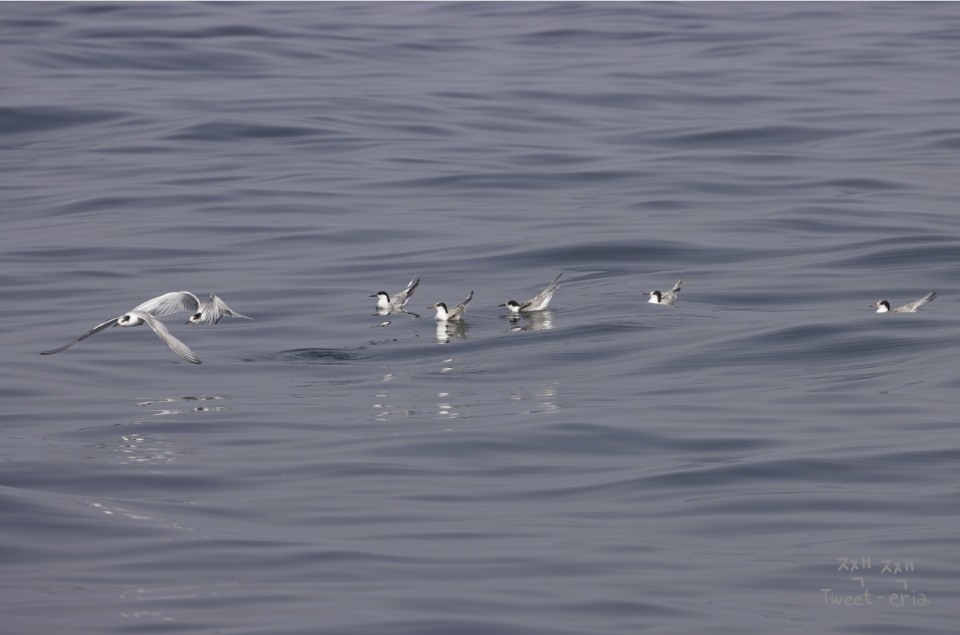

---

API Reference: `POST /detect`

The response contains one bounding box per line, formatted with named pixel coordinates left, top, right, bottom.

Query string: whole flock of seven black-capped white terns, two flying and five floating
left=40, top=273, right=937, bottom=364
